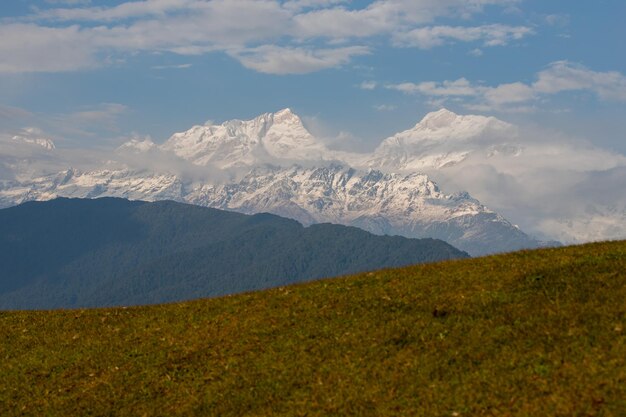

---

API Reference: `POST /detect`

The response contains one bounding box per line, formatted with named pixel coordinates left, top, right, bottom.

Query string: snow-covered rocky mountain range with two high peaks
left=0, top=109, right=541, bottom=255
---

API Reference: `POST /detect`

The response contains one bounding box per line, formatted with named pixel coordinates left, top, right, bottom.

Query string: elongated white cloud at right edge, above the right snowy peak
left=387, top=61, right=626, bottom=112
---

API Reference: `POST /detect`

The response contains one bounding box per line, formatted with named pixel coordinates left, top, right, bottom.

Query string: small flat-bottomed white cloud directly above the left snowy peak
left=231, top=45, right=370, bottom=74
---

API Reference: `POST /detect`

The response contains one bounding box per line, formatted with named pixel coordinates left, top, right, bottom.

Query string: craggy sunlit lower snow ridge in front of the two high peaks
left=188, top=165, right=480, bottom=224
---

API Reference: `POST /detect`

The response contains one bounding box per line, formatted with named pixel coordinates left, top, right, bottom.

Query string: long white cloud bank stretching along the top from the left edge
left=0, top=0, right=528, bottom=74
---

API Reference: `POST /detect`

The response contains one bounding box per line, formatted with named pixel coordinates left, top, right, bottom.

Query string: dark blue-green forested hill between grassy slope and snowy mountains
left=0, top=198, right=467, bottom=309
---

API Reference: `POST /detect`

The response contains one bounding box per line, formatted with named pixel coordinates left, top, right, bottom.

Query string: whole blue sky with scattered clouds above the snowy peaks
left=0, top=0, right=626, bottom=153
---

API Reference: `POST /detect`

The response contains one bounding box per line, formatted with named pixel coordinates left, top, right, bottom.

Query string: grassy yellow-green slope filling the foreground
left=0, top=242, right=626, bottom=416
